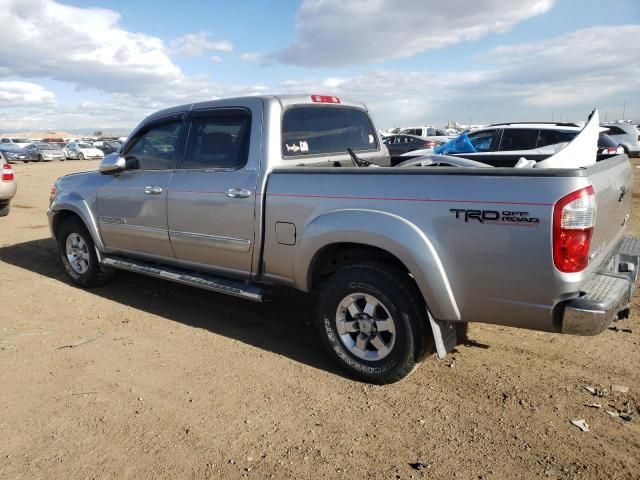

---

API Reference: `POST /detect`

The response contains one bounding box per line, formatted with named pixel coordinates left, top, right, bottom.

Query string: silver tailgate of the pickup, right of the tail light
left=588, top=155, right=633, bottom=259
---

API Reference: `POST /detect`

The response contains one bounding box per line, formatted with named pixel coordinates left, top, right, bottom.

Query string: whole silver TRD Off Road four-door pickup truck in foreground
left=48, top=95, right=640, bottom=383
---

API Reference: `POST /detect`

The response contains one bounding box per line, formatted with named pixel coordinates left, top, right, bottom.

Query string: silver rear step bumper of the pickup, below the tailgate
left=562, top=236, right=640, bottom=335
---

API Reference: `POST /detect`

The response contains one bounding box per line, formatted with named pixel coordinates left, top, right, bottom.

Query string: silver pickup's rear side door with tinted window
left=168, top=102, right=262, bottom=277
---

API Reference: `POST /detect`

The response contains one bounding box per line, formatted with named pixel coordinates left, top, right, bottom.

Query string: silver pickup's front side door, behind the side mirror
left=97, top=118, right=182, bottom=258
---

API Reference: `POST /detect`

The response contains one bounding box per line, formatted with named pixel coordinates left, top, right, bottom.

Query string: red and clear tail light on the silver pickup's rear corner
left=553, top=186, right=596, bottom=273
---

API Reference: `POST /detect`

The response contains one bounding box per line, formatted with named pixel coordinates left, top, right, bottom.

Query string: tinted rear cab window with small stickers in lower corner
left=282, top=105, right=379, bottom=159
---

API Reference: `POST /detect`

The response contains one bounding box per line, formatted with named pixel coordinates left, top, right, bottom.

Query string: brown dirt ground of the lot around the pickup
left=0, top=161, right=640, bottom=479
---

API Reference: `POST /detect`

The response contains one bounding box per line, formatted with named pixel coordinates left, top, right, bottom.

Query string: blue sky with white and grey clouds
left=0, top=0, right=640, bottom=131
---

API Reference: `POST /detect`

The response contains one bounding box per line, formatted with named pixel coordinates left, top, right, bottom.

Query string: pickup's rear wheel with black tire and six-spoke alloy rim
left=316, top=262, right=432, bottom=384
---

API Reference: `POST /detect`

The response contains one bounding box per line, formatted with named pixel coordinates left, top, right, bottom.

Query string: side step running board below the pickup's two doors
left=101, top=257, right=265, bottom=302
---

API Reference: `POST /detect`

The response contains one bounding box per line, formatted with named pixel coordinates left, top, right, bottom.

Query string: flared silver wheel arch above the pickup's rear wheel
left=294, top=209, right=460, bottom=320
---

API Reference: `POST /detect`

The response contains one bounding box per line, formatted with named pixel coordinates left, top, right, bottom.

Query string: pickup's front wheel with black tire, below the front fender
left=56, top=218, right=113, bottom=288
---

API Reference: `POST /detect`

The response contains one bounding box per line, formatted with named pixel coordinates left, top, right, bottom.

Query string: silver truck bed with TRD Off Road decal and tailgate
left=264, top=155, right=633, bottom=331
